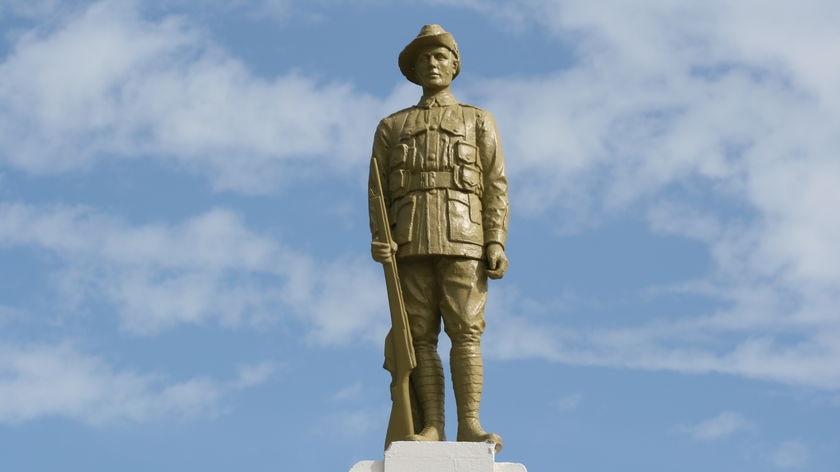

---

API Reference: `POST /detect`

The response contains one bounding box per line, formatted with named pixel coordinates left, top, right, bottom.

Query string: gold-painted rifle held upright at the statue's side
left=369, top=158, right=417, bottom=449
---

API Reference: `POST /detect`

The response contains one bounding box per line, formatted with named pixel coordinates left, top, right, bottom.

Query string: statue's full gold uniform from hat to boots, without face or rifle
left=371, top=25, right=509, bottom=447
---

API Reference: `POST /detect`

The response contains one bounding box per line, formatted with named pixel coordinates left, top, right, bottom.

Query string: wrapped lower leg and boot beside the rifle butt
left=406, top=347, right=446, bottom=441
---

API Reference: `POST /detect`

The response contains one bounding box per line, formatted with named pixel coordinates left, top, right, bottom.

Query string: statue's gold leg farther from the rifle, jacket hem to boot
left=439, top=258, right=502, bottom=452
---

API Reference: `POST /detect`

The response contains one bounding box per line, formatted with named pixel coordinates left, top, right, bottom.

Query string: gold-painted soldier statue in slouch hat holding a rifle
left=369, top=25, right=509, bottom=451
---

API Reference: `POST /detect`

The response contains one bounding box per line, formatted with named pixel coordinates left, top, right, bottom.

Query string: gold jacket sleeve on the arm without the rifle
left=476, top=110, right=510, bottom=246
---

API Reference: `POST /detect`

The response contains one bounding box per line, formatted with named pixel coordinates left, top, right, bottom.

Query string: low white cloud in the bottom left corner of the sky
left=0, top=343, right=268, bottom=425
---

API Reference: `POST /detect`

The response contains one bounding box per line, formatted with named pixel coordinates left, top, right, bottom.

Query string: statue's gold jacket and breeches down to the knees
left=371, top=87, right=508, bottom=344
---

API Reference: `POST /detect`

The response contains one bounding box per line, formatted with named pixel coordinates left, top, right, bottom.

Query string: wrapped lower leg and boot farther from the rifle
left=450, top=345, right=502, bottom=452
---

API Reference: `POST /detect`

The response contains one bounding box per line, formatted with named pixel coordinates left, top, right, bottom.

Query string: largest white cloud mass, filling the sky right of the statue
left=440, top=0, right=840, bottom=389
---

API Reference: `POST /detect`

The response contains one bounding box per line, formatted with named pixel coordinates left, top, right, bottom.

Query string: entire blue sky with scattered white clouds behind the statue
left=0, top=0, right=840, bottom=472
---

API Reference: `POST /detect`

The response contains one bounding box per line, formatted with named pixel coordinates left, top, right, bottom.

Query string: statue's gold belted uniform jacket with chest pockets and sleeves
left=371, top=93, right=509, bottom=259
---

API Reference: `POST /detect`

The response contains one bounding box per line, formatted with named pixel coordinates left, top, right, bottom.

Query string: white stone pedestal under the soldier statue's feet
left=350, top=441, right=527, bottom=472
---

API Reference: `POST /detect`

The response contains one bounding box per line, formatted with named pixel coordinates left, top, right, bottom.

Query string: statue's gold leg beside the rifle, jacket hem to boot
left=399, top=258, right=446, bottom=441
